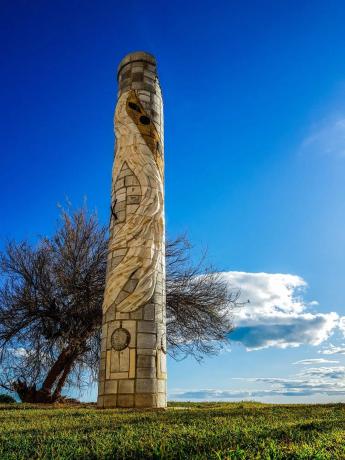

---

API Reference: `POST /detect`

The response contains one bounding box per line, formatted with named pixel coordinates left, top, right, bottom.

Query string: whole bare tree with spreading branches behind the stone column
left=0, top=208, right=238, bottom=402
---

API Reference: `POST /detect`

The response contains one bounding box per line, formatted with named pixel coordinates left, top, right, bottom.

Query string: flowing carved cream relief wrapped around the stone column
left=103, top=90, right=164, bottom=313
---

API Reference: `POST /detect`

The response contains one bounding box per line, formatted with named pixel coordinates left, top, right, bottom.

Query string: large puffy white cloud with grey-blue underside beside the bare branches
left=223, top=272, right=339, bottom=350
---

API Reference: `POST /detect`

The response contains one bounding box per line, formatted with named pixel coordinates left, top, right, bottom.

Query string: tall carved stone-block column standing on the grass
left=98, top=52, right=167, bottom=408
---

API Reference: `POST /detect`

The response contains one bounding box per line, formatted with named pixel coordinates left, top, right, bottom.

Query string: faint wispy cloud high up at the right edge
left=301, top=114, right=345, bottom=157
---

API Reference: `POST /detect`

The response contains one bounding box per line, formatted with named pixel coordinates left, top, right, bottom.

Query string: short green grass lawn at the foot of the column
left=0, top=403, right=345, bottom=460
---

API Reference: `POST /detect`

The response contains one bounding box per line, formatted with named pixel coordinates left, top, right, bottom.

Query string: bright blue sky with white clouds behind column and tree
left=0, top=0, right=345, bottom=402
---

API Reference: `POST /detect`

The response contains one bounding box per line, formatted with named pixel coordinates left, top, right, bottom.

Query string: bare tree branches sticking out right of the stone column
left=166, top=236, right=236, bottom=361
